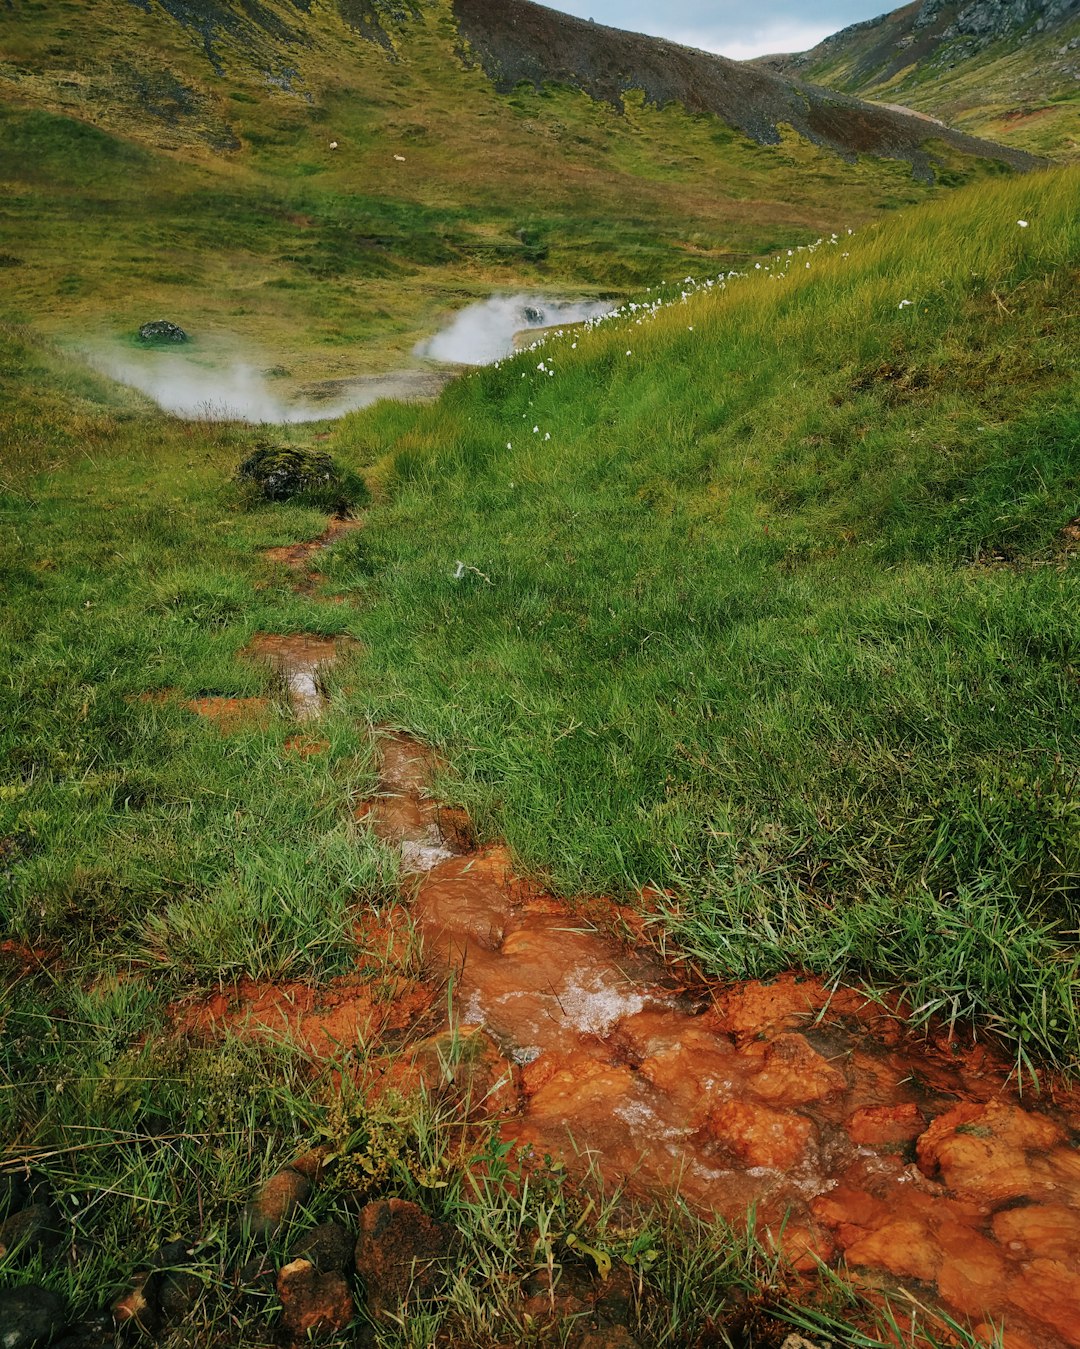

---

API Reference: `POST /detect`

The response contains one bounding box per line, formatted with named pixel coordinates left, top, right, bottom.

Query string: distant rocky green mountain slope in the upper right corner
left=755, top=0, right=1080, bottom=158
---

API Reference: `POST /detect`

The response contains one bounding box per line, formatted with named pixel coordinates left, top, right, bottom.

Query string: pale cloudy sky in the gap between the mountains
left=542, top=0, right=902, bottom=61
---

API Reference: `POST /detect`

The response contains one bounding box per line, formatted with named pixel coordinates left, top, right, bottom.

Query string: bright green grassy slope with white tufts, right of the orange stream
left=334, top=165, right=1080, bottom=1063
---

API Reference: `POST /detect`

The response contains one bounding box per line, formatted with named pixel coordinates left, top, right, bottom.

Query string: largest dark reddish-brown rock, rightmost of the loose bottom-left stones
left=355, top=1199, right=449, bottom=1317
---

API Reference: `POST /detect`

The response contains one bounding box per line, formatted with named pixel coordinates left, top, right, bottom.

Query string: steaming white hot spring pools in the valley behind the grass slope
left=86, top=295, right=615, bottom=424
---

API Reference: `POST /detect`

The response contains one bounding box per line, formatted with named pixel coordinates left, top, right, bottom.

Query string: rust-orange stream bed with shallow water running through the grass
left=202, top=515, right=1080, bottom=1349
